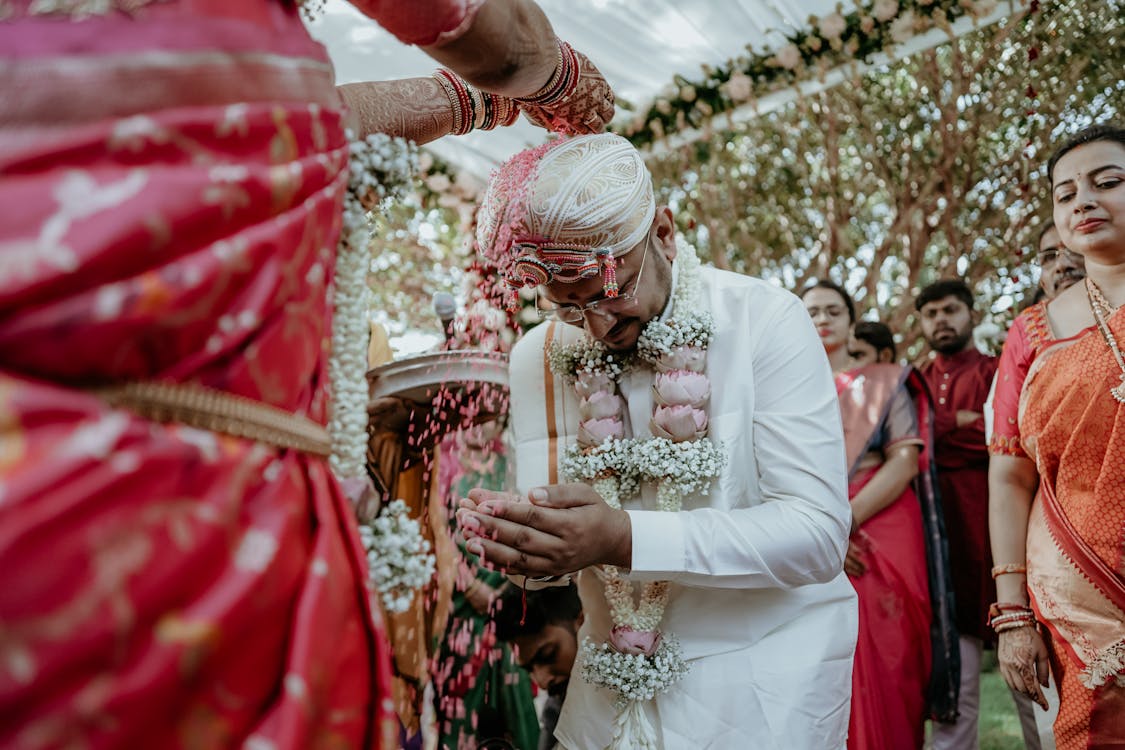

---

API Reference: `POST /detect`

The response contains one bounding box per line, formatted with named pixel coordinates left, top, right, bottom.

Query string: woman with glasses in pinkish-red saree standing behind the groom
left=802, top=281, right=959, bottom=750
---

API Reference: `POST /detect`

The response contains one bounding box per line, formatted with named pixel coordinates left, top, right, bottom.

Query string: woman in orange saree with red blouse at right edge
left=989, top=126, right=1125, bottom=750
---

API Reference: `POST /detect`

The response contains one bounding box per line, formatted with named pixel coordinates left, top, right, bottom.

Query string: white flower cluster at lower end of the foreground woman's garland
left=359, top=500, right=437, bottom=612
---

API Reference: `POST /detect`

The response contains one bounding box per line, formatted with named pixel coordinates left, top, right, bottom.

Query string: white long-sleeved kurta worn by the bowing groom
left=511, top=268, right=858, bottom=750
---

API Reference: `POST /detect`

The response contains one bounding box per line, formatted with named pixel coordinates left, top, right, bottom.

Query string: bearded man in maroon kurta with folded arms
left=915, top=279, right=997, bottom=750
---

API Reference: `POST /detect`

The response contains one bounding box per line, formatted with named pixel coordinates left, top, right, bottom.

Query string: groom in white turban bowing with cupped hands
left=458, top=134, right=857, bottom=750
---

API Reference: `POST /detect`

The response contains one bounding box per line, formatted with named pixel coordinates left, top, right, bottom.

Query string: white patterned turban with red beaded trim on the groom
left=477, top=133, right=656, bottom=286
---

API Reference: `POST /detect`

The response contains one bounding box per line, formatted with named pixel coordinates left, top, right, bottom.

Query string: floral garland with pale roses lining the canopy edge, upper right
left=612, top=0, right=1027, bottom=146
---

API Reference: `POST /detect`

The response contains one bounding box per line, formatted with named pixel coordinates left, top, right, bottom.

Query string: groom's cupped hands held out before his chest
left=457, top=484, right=632, bottom=578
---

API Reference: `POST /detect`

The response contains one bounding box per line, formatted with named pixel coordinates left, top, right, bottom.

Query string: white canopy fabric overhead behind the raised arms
left=309, top=0, right=1019, bottom=180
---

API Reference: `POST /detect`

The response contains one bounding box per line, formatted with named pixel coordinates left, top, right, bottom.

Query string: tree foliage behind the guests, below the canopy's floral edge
left=649, top=0, right=1125, bottom=354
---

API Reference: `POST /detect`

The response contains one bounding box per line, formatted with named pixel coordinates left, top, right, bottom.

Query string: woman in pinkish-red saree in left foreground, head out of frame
left=0, top=0, right=612, bottom=750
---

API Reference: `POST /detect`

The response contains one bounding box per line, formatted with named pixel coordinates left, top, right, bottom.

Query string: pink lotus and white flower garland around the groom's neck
left=548, top=241, right=726, bottom=750
